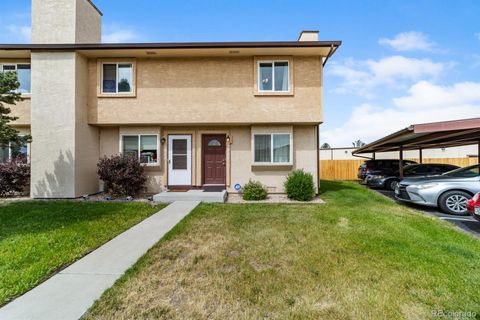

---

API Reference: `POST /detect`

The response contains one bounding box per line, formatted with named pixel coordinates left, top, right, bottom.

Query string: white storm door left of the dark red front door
left=168, top=135, right=192, bottom=186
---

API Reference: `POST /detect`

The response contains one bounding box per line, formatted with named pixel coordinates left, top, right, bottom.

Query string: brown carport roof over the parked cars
left=352, top=118, right=480, bottom=155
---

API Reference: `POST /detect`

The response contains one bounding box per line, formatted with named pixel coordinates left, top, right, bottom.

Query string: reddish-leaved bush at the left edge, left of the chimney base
left=0, top=157, right=30, bottom=197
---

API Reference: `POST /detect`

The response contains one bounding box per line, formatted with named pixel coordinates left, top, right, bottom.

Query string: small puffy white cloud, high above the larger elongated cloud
left=378, top=31, right=435, bottom=51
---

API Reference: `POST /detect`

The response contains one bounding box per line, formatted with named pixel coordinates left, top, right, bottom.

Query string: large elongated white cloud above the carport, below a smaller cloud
left=328, top=55, right=447, bottom=97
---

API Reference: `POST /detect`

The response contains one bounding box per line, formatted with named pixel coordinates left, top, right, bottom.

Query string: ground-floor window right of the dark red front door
left=254, top=133, right=291, bottom=163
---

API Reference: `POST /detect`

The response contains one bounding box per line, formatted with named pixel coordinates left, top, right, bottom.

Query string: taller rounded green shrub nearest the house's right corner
left=284, top=170, right=315, bottom=201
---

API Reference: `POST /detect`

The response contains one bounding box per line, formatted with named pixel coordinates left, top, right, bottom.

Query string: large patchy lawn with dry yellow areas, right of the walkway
left=86, top=181, right=480, bottom=319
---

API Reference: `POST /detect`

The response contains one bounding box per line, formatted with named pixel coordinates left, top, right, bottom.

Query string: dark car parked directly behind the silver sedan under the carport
left=366, top=163, right=459, bottom=190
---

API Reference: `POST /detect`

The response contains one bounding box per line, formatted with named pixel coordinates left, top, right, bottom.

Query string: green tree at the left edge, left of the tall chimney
left=0, top=71, right=31, bottom=147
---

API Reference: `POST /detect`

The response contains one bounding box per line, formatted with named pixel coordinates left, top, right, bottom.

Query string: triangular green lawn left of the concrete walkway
left=0, top=201, right=161, bottom=305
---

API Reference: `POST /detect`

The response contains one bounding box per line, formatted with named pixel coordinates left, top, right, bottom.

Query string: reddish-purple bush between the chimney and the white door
left=97, top=155, right=147, bottom=197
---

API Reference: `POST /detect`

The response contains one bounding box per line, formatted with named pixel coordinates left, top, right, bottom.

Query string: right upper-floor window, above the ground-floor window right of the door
left=258, top=61, right=289, bottom=92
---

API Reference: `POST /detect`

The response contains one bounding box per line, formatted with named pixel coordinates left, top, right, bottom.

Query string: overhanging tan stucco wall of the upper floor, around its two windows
left=89, top=56, right=323, bottom=125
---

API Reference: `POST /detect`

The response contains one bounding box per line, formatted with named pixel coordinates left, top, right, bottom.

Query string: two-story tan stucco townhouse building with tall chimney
left=0, top=0, right=340, bottom=198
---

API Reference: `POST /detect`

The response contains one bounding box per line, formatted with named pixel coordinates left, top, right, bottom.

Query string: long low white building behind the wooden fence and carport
left=320, top=145, right=478, bottom=160
